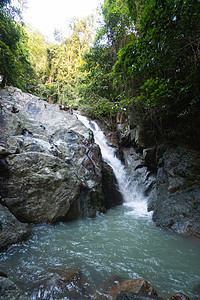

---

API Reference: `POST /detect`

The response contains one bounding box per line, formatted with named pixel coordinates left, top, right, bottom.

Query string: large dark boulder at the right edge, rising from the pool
left=149, top=146, right=200, bottom=237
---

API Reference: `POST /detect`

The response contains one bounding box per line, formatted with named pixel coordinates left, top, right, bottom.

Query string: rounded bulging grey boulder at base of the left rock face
left=2, top=152, right=80, bottom=223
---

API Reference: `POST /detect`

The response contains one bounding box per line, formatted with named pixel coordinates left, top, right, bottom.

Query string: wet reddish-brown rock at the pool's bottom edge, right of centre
left=94, top=278, right=157, bottom=300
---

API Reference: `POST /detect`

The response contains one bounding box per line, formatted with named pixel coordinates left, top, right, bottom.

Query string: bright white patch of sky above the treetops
left=20, top=0, right=103, bottom=41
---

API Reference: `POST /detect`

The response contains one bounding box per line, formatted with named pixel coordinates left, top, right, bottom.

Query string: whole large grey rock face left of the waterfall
left=0, top=87, right=112, bottom=223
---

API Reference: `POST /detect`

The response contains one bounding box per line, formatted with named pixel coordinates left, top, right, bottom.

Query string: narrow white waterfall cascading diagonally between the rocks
left=77, top=114, right=151, bottom=217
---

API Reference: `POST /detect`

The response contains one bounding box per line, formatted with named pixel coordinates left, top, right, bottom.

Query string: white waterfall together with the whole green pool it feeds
left=0, top=116, right=200, bottom=300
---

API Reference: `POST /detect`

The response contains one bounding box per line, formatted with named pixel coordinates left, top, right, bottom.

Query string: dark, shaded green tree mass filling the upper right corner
left=115, top=0, right=200, bottom=139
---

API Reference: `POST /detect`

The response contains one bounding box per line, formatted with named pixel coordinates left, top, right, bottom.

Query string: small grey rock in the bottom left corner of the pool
left=0, top=277, right=29, bottom=300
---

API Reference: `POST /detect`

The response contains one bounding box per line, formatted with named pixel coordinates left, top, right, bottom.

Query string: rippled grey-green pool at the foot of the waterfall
left=0, top=206, right=200, bottom=299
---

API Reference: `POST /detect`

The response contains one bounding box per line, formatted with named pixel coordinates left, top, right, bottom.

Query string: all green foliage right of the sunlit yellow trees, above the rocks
left=80, top=0, right=200, bottom=142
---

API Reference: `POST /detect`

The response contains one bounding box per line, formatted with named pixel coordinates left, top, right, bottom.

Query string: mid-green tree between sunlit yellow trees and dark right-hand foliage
left=77, top=0, right=135, bottom=117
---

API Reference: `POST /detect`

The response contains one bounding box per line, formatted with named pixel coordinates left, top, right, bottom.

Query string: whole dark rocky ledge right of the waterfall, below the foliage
left=116, top=111, right=200, bottom=237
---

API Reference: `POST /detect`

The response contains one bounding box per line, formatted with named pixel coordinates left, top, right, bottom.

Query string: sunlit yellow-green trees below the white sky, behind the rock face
left=29, top=17, right=93, bottom=104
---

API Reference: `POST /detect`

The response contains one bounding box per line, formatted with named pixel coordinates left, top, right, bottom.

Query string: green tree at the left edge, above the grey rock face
left=0, top=1, right=34, bottom=89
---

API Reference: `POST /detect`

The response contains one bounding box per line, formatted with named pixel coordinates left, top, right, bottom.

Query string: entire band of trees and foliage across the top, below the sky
left=0, top=0, right=200, bottom=142
